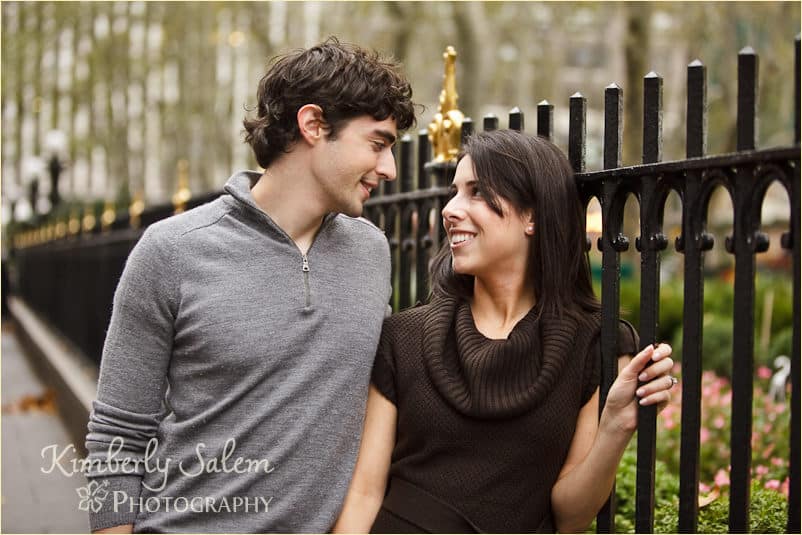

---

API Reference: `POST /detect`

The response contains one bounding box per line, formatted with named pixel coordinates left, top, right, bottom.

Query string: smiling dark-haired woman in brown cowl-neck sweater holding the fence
left=334, top=130, right=676, bottom=533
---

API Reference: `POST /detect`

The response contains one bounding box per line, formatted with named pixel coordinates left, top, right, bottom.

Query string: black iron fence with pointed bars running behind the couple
left=9, top=38, right=801, bottom=533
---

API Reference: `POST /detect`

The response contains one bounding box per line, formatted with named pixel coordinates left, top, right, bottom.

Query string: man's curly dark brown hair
left=243, top=37, right=415, bottom=169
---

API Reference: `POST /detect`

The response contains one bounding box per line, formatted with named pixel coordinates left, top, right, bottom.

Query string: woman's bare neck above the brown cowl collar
left=471, top=277, right=537, bottom=340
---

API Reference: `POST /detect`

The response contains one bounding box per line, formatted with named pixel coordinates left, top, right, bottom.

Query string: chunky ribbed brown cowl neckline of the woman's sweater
left=423, top=297, right=577, bottom=419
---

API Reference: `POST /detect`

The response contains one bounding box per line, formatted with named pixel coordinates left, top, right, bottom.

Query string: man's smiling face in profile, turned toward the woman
left=313, top=115, right=398, bottom=217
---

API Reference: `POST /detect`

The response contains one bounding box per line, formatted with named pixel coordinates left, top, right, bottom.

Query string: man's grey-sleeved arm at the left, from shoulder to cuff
left=86, top=225, right=177, bottom=532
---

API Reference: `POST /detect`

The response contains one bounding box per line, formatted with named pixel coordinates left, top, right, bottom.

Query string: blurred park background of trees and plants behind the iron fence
left=0, top=1, right=800, bottom=532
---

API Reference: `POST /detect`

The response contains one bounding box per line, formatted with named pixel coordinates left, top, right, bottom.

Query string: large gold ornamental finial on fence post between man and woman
left=428, top=46, right=465, bottom=162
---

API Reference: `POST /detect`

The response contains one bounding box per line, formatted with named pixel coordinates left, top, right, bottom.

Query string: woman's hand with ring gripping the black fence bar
left=599, top=344, right=676, bottom=435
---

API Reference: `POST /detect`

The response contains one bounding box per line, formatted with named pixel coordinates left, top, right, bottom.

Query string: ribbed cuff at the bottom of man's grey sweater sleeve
left=89, top=475, right=142, bottom=531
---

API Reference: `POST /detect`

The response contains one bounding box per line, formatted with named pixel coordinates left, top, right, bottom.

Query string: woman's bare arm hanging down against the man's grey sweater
left=332, top=385, right=397, bottom=533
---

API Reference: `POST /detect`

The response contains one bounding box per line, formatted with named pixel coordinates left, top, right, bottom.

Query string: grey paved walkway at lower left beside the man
left=0, top=324, right=89, bottom=533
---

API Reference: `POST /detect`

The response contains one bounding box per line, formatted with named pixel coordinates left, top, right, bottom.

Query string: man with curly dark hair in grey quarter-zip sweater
left=86, top=39, right=414, bottom=532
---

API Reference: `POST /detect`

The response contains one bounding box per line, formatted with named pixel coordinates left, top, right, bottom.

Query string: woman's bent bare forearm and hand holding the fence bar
left=551, top=344, right=674, bottom=533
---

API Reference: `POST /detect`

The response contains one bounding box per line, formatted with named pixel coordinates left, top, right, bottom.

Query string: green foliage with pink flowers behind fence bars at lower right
left=591, top=368, right=790, bottom=533
